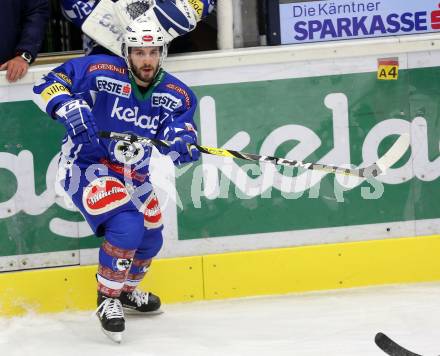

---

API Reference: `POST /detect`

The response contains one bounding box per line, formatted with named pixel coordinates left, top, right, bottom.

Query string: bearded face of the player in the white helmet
left=128, top=47, right=161, bottom=84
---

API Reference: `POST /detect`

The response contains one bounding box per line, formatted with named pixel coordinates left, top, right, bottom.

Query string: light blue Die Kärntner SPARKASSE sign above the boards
left=280, top=0, right=440, bottom=44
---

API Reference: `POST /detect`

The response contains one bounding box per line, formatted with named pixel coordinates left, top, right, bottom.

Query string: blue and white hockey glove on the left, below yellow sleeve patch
left=55, top=99, right=98, bottom=144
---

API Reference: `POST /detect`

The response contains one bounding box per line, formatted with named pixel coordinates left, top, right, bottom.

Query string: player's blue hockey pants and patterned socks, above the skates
left=63, top=171, right=163, bottom=297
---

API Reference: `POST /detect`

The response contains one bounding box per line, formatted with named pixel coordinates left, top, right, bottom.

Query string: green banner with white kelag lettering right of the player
left=179, top=68, right=440, bottom=239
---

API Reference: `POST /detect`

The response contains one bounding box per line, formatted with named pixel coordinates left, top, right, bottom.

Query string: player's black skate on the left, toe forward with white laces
left=96, top=292, right=125, bottom=343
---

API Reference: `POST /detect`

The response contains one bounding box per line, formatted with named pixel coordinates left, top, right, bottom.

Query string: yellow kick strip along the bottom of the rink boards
left=0, top=235, right=440, bottom=316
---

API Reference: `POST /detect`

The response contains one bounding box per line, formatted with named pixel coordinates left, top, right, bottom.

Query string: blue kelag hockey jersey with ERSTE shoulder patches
left=34, top=55, right=197, bottom=184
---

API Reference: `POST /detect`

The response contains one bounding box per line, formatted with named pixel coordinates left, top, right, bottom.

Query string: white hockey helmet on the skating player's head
left=121, top=16, right=168, bottom=75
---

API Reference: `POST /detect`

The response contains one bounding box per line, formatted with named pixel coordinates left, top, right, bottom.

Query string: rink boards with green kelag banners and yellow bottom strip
left=0, top=35, right=440, bottom=314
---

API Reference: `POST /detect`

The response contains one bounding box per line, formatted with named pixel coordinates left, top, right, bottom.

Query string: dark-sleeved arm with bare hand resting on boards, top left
left=0, top=0, right=49, bottom=82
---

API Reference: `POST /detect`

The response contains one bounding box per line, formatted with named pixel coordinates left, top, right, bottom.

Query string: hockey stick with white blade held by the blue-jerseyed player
left=99, top=131, right=409, bottom=178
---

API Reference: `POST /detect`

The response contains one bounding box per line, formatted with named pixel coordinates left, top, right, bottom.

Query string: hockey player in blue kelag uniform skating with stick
left=34, top=19, right=200, bottom=342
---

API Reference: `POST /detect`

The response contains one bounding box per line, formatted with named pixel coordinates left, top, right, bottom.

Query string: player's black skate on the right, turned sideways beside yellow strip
left=119, top=289, right=162, bottom=315
